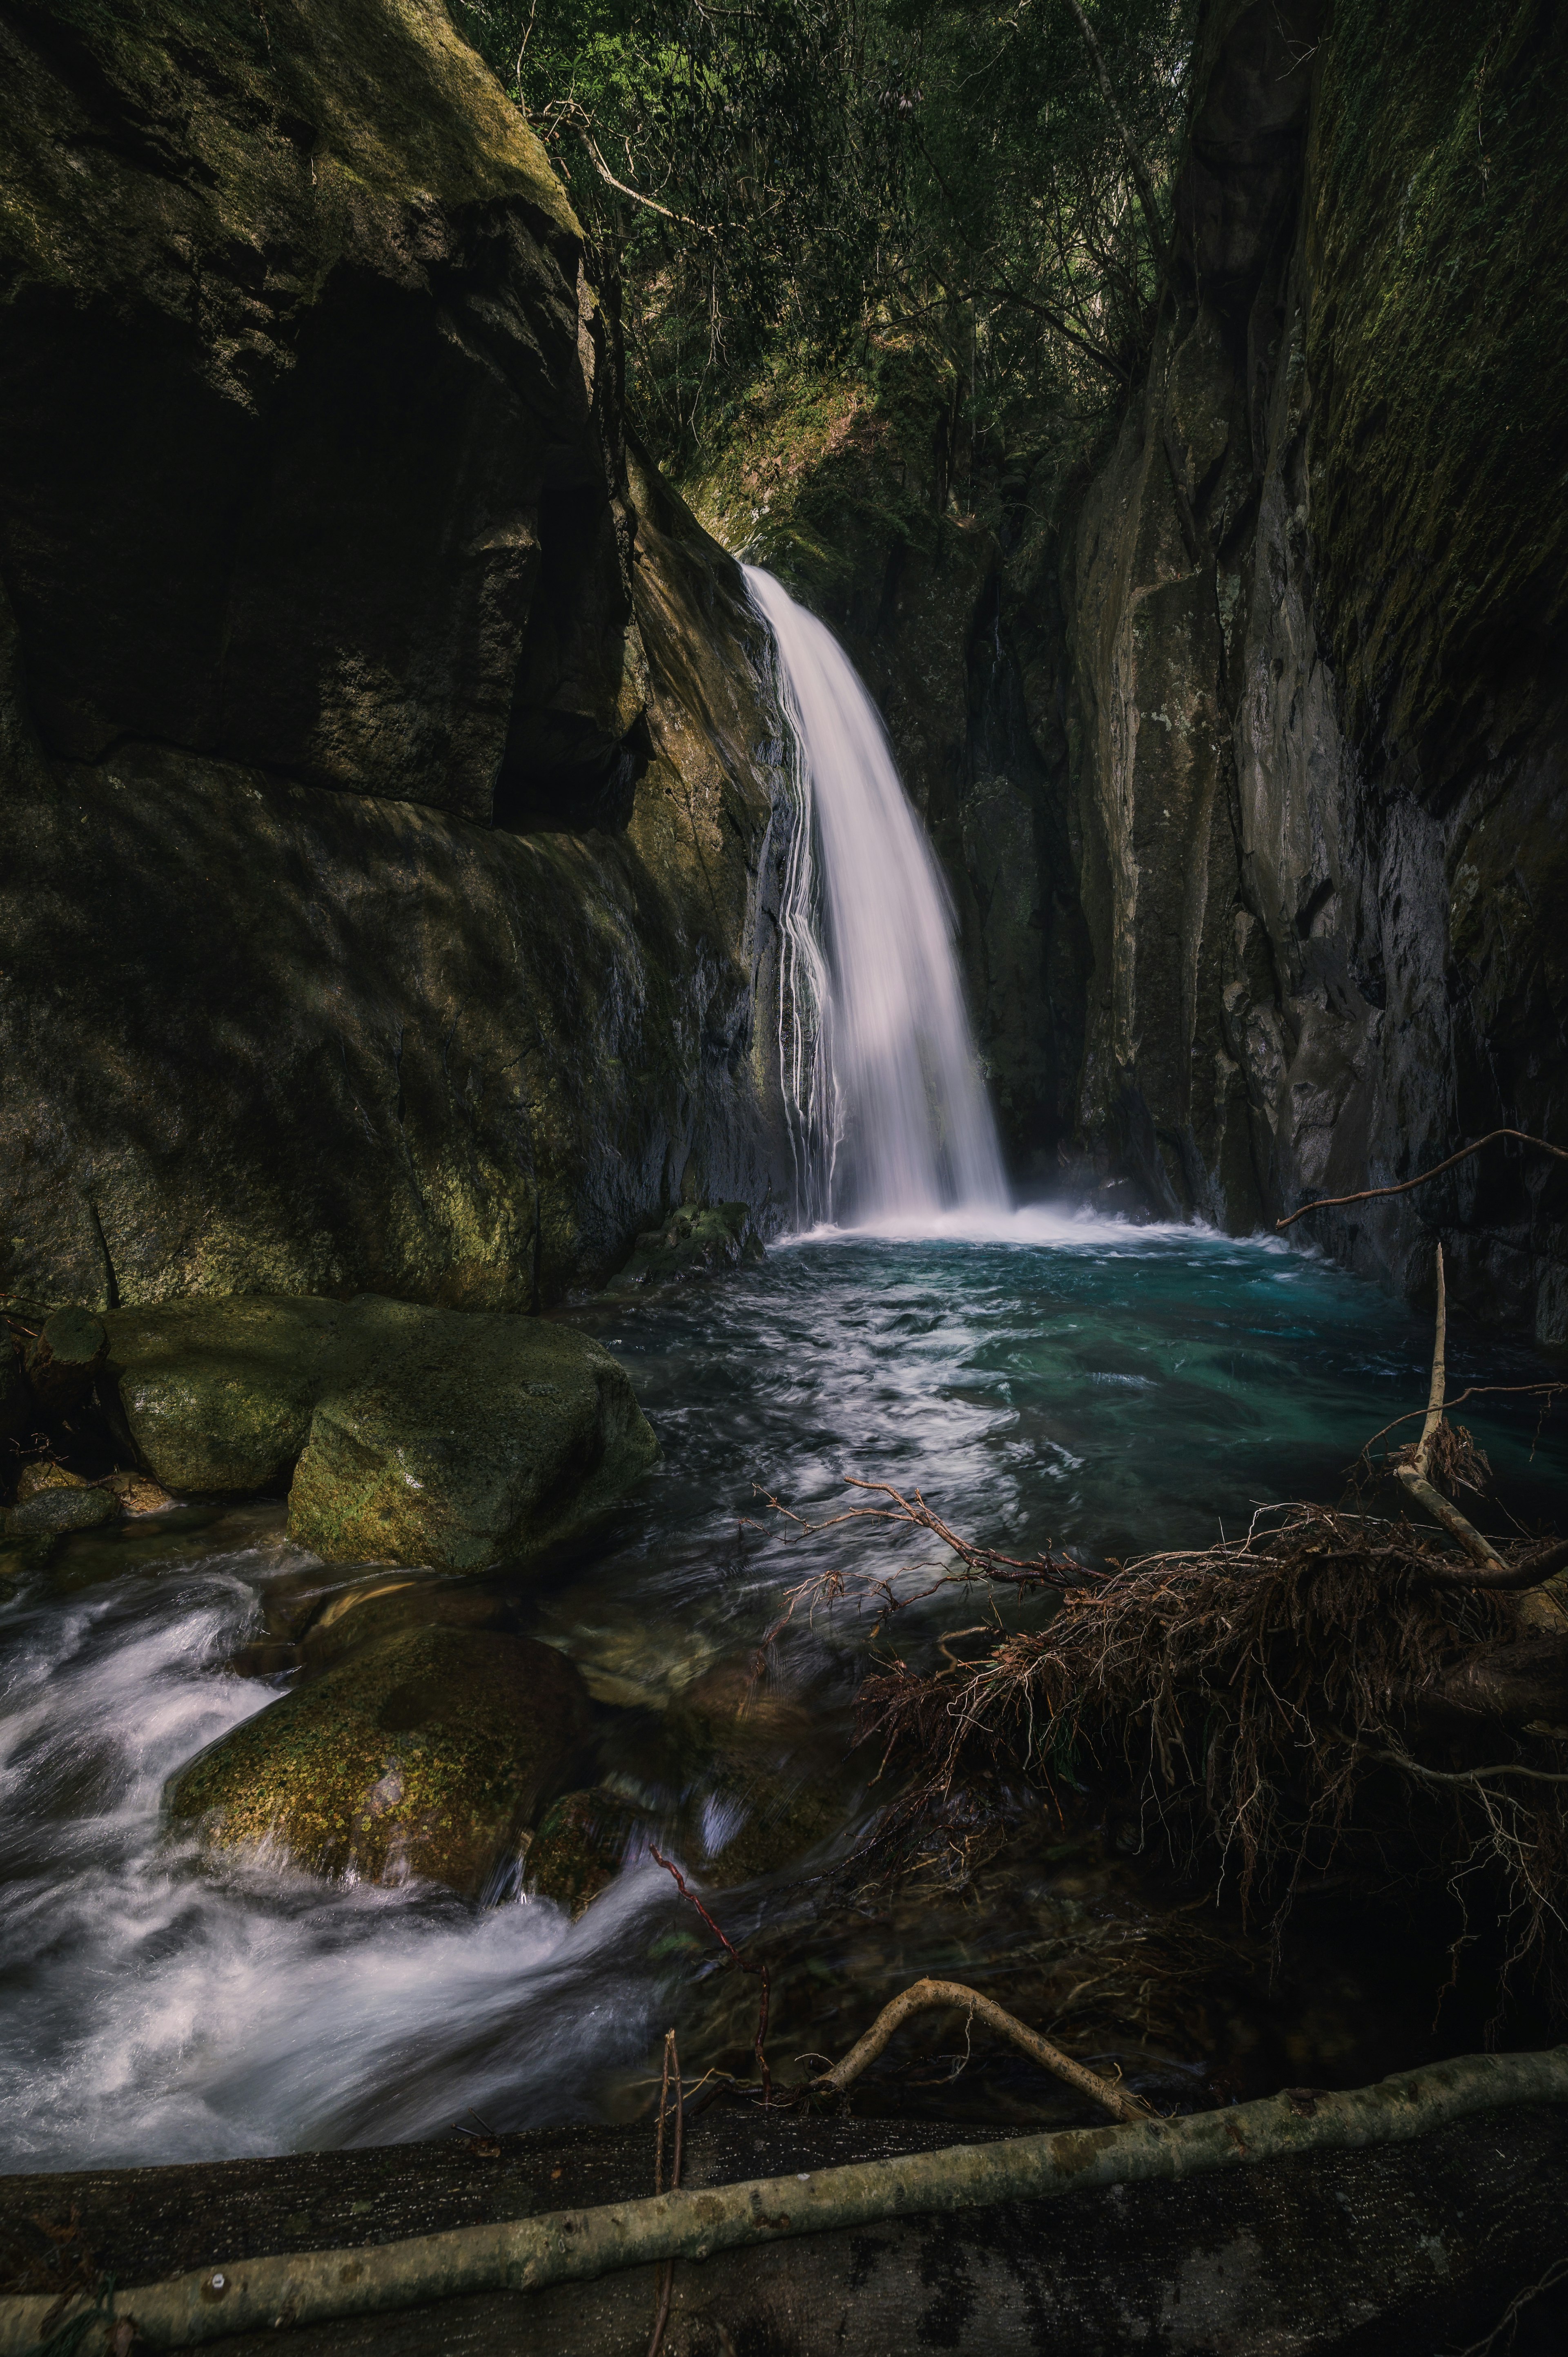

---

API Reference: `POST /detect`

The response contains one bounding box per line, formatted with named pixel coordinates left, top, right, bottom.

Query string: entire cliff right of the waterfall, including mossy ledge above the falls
left=695, top=0, right=1568, bottom=1343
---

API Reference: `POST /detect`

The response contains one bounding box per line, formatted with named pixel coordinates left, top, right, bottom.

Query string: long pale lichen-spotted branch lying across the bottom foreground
left=0, top=2046, right=1568, bottom=2357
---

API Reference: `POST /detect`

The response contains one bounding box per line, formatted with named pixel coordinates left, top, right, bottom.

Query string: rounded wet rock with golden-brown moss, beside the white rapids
left=167, top=1626, right=590, bottom=1898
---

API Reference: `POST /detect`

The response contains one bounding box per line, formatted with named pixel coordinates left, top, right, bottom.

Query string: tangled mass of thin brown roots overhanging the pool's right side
left=861, top=1504, right=1568, bottom=1963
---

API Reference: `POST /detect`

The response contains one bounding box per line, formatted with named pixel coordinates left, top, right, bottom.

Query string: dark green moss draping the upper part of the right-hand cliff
left=1309, top=0, right=1568, bottom=773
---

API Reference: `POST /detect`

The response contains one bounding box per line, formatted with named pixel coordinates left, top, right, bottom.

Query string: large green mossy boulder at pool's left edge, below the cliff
left=106, top=1296, right=658, bottom=1572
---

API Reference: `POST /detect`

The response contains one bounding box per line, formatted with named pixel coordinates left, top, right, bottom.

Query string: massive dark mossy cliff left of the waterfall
left=0, top=0, right=776, bottom=1308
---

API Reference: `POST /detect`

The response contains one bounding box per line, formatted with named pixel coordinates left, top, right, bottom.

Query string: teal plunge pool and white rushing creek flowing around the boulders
left=0, top=1211, right=1563, bottom=2168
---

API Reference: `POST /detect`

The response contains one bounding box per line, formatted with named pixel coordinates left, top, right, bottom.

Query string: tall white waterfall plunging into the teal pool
left=745, top=566, right=1009, bottom=1228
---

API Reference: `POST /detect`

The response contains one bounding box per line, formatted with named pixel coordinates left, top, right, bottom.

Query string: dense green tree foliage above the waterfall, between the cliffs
left=462, top=0, right=1196, bottom=457
